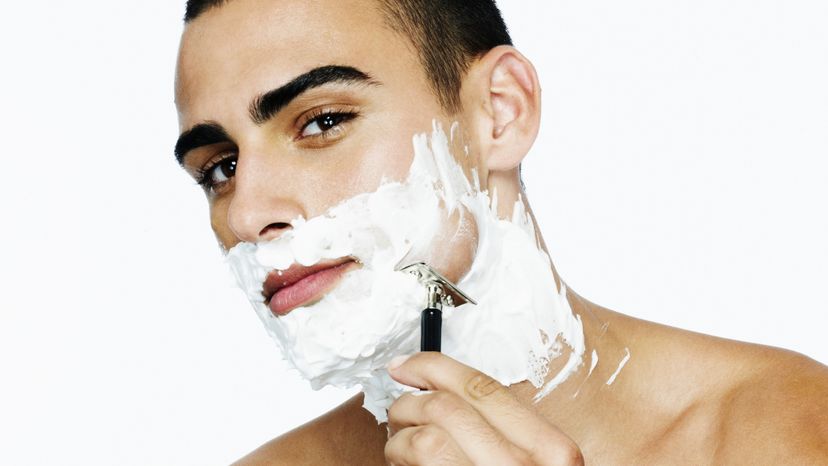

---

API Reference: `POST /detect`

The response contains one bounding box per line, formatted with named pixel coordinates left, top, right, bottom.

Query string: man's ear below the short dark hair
left=461, top=45, right=541, bottom=172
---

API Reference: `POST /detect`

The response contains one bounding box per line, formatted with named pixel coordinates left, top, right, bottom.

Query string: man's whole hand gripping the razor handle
left=385, top=352, right=584, bottom=466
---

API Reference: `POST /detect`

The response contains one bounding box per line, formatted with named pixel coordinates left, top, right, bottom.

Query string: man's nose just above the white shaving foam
left=227, top=151, right=305, bottom=243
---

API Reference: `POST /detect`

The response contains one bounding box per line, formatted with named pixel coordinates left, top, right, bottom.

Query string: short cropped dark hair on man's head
left=184, top=0, right=512, bottom=112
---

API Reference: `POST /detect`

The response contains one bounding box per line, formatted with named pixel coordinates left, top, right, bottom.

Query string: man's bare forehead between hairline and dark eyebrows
left=176, top=0, right=416, bottom=123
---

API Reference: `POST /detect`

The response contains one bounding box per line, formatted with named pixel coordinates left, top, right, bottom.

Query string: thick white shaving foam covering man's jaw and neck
left=227, top=123, right=584, bottom=422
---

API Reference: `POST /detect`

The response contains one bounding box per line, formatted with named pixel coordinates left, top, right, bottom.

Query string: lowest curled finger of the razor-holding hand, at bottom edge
left=385, top=424, right=474, bottom=466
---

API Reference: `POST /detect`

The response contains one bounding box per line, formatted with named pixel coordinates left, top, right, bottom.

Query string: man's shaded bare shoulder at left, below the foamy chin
left=233, top=396, right=387, bottom=466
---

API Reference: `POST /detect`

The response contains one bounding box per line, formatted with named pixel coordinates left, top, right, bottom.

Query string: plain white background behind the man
left=0, top=0, right=828, bottom=465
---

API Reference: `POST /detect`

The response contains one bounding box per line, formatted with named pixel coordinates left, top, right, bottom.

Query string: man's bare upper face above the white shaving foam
left=176, top=0, right=471, bottom=278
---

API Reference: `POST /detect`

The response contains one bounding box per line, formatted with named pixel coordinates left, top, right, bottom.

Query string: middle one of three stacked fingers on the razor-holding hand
left=388, top=391, right=529, bottom=466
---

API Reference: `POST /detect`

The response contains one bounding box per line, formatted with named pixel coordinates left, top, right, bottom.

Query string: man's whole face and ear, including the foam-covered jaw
left=176, top=0, right=564, bottom=420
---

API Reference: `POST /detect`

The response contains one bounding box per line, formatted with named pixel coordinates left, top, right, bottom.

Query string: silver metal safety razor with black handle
left=399, top=262, right=477, bottom=353
